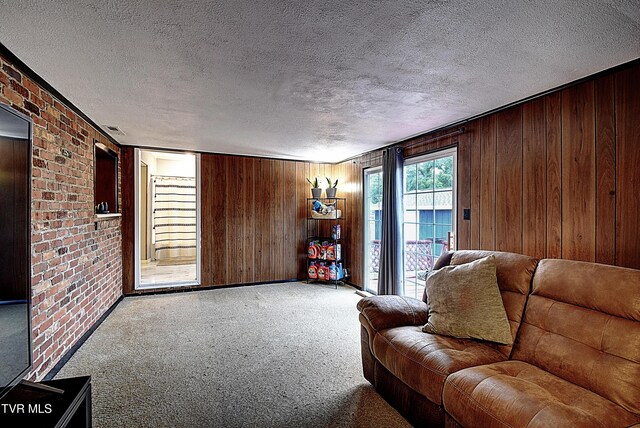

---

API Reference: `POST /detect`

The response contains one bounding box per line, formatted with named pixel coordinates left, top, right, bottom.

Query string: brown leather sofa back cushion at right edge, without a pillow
left=511, top=259, right=640, bottom=414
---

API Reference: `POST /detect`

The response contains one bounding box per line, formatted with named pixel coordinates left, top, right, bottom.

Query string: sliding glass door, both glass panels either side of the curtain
left=364, top=148, right=457, bottom=299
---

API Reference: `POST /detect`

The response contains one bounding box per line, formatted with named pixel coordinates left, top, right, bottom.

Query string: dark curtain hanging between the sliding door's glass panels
left=378, top=147, right=404, bottom=295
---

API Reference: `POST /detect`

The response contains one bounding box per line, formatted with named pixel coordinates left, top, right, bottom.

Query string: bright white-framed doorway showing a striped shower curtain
left=135, top=149, right=200, bottom=289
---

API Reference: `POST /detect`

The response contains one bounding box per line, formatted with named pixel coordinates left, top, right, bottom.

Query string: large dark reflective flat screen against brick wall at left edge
left=0, top=103, right=32, bottom=400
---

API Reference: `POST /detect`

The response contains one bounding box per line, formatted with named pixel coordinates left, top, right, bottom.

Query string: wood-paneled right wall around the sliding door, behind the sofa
left=342, top=61, right=640, bottom=286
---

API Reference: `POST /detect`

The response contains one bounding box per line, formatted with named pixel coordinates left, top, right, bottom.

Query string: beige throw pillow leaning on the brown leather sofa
left=422, top=256, right=513, bottom=345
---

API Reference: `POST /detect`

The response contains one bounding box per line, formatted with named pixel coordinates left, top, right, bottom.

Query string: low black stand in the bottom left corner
left=0, top=376, right=91, bottom=428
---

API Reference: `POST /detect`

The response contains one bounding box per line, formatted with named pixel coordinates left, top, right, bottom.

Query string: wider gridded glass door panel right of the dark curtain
left=403, top=149, right=456, bottom=299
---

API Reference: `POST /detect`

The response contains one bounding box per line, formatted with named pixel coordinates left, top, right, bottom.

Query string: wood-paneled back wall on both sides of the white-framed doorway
left=122, top=147, right=339, bottom=294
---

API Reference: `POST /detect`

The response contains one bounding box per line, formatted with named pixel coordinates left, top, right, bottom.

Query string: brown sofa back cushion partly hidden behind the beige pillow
left=423, top=250, right=538, bottom=358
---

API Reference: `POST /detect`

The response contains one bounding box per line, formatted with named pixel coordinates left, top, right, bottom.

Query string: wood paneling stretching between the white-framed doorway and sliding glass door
left=201, top=154, right=370, bottom=286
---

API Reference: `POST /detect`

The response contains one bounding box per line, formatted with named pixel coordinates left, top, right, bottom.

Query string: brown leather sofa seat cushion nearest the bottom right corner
left=443, top=360, right=640, bottom=428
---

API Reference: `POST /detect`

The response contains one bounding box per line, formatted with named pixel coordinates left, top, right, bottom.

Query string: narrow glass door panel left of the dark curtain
left=364, top=168, right=382, bottom=293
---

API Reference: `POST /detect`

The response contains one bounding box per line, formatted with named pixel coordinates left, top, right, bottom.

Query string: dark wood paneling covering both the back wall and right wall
left=123, top=61, right=640, bottom=293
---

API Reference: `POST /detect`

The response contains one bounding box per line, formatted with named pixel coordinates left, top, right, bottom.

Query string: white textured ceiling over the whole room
left=0, top=0, right=640, bottom=161
